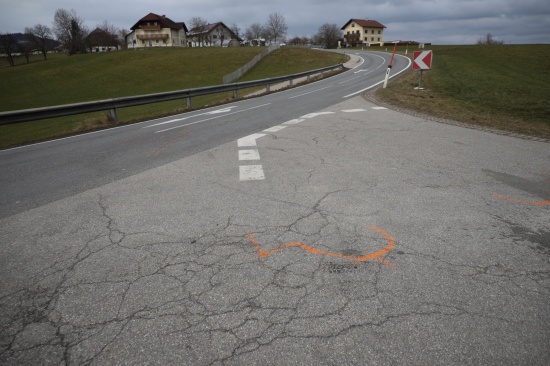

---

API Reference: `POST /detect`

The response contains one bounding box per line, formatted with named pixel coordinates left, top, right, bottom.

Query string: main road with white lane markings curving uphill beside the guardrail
left=0, top=52, right=410, bottom=218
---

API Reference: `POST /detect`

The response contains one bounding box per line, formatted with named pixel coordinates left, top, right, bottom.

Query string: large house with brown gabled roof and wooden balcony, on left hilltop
left=126, top=13, right=187, bottom=48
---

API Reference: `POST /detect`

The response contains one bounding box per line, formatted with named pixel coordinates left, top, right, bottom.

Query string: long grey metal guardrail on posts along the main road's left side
left=0, top=64, right=344, bottom=125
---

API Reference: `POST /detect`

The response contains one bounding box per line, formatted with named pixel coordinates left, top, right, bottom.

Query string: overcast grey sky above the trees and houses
left=0, top=0, right=550, bottom=44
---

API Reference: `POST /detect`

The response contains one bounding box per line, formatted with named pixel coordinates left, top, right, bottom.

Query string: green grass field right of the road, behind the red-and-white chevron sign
left=375, top=45, right=550, bottom=138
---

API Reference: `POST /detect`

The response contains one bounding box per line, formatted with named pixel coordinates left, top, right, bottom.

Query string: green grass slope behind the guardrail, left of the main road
left=0, top=47, right=343, bottom=148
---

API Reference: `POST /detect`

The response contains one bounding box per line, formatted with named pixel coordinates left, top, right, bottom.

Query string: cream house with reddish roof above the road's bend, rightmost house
left=341, top=19, right=386, bottom=47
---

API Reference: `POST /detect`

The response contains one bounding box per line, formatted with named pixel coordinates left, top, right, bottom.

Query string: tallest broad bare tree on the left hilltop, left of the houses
left=53, top=9, right=88, bottom=55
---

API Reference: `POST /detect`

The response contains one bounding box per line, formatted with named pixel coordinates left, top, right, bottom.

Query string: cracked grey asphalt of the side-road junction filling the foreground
left=0, top=97, right=550, bottom=365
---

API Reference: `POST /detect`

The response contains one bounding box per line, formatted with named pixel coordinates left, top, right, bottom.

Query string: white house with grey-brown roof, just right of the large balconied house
left=187, top=22, right=242, bottom=47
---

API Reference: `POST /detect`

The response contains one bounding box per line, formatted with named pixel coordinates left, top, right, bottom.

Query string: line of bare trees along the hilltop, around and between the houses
left=0, top=9, right=341, bottom=66
